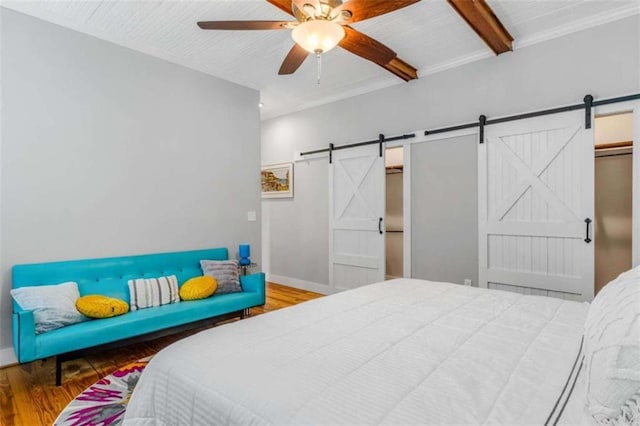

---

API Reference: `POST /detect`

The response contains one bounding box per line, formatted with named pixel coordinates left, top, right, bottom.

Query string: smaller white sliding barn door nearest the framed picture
left=329, top=144, right=385, bottom=290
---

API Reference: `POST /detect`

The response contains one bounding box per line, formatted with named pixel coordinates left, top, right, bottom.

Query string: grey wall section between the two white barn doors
left=411, top=135, right=478, bottom=286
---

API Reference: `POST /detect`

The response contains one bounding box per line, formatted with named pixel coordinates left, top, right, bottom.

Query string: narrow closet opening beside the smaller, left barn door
left=385, top=146, right=404, bottom=279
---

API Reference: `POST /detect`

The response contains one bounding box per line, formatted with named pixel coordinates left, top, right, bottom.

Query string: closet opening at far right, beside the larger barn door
left=594, top=112, right=637, bottom=294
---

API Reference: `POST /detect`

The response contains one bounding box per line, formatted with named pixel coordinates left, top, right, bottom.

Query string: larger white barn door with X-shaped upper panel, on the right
left=478, top=110, right=594, bottom=300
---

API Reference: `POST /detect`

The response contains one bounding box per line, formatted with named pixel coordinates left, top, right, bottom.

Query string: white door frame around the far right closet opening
left=593, top=100, right=640, bottom=267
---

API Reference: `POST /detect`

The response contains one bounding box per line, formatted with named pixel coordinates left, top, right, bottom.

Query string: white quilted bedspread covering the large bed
left=125, top=279, right=588, bottom=425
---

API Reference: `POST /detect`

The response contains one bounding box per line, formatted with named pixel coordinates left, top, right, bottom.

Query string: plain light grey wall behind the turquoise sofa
left=0, top=9, right=262, bottom=362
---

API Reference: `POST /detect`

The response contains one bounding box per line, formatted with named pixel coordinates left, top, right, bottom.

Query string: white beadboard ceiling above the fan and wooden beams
left=1, top=0, right=640, bottom=119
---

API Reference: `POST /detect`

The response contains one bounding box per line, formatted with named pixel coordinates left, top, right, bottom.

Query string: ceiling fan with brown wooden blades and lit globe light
left=198, top=0, right=420, bottom=81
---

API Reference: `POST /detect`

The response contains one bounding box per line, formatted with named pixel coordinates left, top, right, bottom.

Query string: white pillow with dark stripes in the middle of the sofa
left=128, top=275, right=180, bottom=311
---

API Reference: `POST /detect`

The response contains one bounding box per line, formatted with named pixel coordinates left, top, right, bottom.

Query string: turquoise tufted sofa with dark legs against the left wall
left=12, top=248, right=265, bottom=385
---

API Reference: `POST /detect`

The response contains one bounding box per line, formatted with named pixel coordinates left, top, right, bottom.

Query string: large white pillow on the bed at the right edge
left=585, top=266, right=640, bottom=424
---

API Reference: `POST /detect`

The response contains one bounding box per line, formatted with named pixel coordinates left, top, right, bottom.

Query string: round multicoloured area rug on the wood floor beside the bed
left=54, top=357, right=151, bottom=426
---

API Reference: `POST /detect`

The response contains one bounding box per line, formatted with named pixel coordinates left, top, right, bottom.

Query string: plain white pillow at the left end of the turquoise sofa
left=10, top=281, right=88, bottom=334
